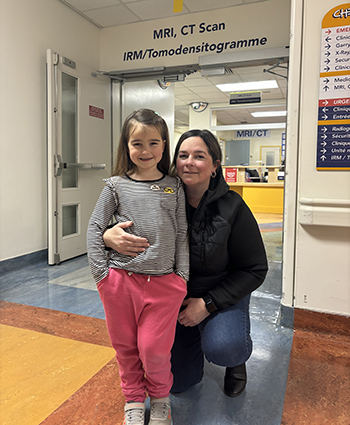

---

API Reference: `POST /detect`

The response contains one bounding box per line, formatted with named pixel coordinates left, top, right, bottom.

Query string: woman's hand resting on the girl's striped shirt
left=103, top=221, right=149, bottom=257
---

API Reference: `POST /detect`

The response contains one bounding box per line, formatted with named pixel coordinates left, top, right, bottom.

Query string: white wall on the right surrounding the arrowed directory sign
left=284, top=0, right=350, bottom=315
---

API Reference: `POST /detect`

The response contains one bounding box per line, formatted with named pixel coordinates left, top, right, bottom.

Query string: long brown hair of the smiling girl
left=112, top=109, right=170, bottom=176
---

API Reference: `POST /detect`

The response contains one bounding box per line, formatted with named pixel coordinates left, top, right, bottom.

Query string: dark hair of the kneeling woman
left=170, top=130, right=222, bottom=176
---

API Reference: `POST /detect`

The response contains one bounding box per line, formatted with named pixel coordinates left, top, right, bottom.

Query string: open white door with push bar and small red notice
left=47, top=49, right=111, bottom=264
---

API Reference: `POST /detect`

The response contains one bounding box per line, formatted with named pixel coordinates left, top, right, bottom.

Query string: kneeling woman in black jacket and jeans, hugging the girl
left=104, top=130, right=268, bottom=397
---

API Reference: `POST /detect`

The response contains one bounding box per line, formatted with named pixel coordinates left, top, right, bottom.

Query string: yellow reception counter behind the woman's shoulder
left=228, top=182, right=284, bottom=214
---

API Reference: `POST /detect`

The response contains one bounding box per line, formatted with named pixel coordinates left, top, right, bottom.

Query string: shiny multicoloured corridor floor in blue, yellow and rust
left=0, top=214, right=350, bottom=425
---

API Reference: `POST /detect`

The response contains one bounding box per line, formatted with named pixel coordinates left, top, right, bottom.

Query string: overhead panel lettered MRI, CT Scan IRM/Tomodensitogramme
left=100, top=0, right=290, bottom=71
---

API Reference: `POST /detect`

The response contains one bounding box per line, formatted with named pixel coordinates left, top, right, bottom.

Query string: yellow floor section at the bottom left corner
left=0, top=325, right=115, bottom=425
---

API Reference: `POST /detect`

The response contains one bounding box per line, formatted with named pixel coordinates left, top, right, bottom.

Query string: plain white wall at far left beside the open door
left=0, top=0, right=100, bottom=260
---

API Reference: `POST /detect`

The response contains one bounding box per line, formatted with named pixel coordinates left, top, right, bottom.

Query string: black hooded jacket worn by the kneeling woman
left=187, top=170, right=268, bottom=310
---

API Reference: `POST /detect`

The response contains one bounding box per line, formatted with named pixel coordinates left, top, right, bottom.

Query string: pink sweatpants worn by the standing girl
left=98, top=268, right=187, bottom=402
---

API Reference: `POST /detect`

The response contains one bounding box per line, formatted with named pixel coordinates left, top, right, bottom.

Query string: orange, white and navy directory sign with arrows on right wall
left=316, top=3, right=350, bottom=170
